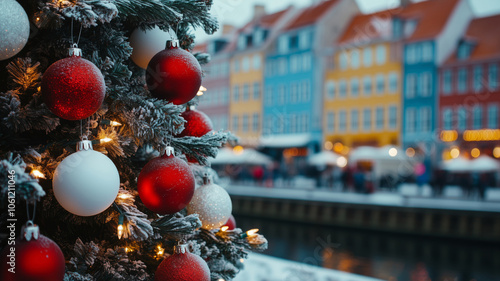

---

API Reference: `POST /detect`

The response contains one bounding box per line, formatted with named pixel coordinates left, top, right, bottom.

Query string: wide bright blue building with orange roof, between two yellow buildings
left=260, top=0, right=359, bottom=166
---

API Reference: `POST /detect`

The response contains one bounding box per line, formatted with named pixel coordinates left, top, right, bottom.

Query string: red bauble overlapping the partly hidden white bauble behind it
left=146, top=40, right=201, bottom=105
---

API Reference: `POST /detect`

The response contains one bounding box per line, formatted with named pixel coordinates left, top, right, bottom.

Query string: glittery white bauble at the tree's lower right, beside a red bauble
left=187, top=176, right=233, bottom=230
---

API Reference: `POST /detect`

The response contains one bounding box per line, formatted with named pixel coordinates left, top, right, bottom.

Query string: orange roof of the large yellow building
left=339, top=9, right=397, bottom=44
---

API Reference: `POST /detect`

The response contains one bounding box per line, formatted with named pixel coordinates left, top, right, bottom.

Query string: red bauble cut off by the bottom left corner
left=0, top=222, right=65, bottom=281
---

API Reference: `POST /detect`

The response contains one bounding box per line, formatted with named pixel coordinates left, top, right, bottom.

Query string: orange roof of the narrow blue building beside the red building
left=396, top=0, right=461, bottom=41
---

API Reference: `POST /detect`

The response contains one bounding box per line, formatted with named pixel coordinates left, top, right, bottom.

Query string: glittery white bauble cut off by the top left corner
left=0, top=0, right=30, bottom=60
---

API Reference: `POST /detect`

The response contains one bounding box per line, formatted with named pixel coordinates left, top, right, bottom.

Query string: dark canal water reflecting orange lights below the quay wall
left=236, top=217, right=500, bottom=281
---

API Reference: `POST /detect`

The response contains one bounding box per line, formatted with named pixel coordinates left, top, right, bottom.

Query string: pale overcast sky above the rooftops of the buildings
left=196, top=0, right=500, bottom=42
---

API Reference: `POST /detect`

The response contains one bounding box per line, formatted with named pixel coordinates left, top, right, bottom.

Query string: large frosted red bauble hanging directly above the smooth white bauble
left=42, top=48, right=106, bottom=120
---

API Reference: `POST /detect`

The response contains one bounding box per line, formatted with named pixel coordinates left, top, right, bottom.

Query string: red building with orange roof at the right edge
left=439, top=15, right=500, bottom=158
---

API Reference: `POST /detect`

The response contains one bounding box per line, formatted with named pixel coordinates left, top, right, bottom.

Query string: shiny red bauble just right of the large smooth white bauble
left=137, top=147, right=195, bottom=215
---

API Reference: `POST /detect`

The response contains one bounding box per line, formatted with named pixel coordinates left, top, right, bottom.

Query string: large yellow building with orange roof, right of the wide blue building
left=323, top=11, right=402, bottom=152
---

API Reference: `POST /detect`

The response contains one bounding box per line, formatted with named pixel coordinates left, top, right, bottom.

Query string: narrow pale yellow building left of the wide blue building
left=229, top=5, right=291, bottom=146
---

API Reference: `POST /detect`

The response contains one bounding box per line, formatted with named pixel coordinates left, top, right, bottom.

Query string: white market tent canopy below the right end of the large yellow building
left=349, top=145, right=415, bottom=178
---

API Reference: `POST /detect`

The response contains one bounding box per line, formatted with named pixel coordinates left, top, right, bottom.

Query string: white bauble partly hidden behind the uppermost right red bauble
left=130, top=27, right=172, bottom=69
